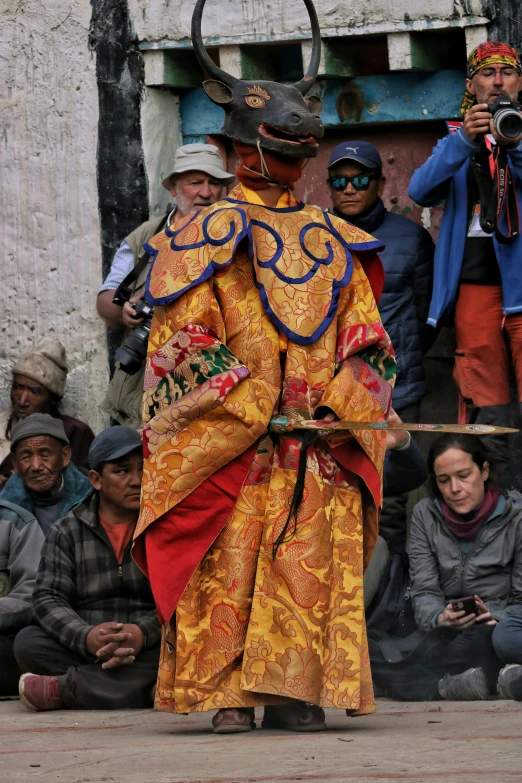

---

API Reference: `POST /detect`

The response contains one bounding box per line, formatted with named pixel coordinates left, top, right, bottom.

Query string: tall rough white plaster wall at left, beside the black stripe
left=0, top=0, right=108, bottom=430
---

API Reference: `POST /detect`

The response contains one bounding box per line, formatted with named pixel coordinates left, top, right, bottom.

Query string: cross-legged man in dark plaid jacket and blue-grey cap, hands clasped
left=15, top=427, right=160, bottom=711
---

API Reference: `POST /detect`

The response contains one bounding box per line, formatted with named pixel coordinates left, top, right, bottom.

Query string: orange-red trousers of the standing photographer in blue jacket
left=453, top=284, right=522, bottom=407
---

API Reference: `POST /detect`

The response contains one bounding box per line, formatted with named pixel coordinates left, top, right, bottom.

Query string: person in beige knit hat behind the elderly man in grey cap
left=0, top=337, right=94, bottom=488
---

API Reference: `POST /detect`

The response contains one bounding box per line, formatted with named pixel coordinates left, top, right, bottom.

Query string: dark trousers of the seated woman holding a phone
left=369, top=625, right=503, bottom=701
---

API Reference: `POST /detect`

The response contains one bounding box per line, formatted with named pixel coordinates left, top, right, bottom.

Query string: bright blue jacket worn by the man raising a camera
left=408, top=129, right=522, bottom=326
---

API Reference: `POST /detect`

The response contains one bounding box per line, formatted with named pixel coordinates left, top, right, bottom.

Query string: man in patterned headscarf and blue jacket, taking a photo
left=408, top=41, right=522, bottom=488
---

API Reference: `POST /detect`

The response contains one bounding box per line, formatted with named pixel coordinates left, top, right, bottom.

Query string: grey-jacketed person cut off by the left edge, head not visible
left=0, top=499, right=44, bottom=696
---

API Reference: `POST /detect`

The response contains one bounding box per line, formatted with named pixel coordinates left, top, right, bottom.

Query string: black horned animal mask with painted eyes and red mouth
left=192, top=0, right=324, bottom=158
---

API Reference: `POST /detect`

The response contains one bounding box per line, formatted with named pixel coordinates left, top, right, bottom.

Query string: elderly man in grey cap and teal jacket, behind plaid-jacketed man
left=0, top=413, right=91, bottom=535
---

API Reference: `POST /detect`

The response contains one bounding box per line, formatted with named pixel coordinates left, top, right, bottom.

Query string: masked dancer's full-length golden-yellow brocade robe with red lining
left=135, top=187, right=395, bottom=714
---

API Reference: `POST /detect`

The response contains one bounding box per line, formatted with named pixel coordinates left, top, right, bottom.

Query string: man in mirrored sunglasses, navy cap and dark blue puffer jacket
left=328, top=141, right=436, bottom=551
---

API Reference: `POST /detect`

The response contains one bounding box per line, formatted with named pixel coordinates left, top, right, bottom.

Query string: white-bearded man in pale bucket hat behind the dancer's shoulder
left=96, top=144, right=235, bottom=428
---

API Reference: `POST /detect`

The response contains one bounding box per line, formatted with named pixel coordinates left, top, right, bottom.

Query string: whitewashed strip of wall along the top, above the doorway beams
left=129, top=0, right=482, bottom=41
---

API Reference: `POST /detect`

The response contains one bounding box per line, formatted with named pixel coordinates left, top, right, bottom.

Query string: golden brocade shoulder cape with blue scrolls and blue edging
left=142, top=186, right=382, bottom=344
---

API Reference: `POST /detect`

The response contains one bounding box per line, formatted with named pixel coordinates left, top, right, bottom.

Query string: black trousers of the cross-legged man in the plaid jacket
left=14, top=625, right=160, bottom=710
